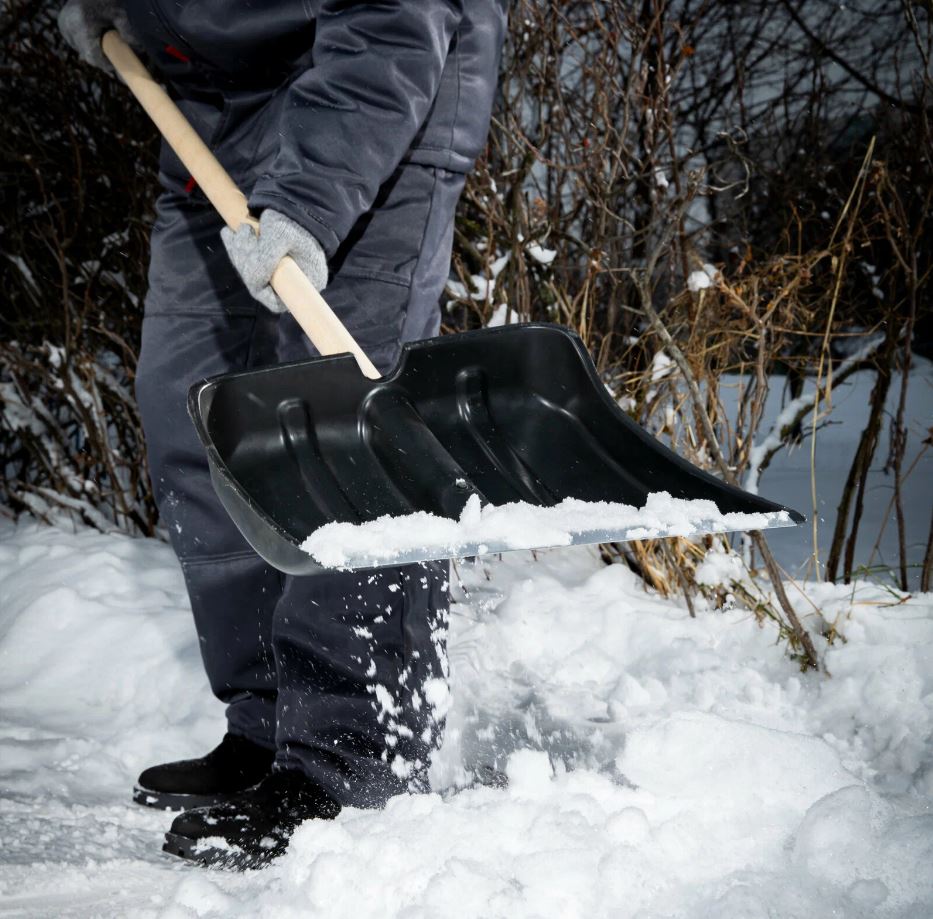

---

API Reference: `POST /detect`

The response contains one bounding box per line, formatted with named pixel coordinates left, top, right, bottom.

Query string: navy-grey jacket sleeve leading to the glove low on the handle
left=250, top=0, right=462, bottom=256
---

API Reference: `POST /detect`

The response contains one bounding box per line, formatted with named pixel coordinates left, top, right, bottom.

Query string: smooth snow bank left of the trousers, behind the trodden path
left=0, top=524, right=220, bottom=803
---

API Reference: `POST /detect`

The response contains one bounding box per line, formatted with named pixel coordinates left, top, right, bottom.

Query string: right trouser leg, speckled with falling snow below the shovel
left=272, top=166, right=463, bottom=806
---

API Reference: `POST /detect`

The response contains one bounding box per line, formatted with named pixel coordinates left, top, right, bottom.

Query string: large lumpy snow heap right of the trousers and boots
left=169, top=550, right=933, bottom=919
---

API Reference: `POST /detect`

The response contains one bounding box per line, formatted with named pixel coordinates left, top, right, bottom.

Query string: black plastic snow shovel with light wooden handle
left=103, top=32, right=803, bottom=574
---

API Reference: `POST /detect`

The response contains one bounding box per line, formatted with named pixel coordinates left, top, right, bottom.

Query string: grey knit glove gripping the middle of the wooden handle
left=220, top=208, right=327, bottom=313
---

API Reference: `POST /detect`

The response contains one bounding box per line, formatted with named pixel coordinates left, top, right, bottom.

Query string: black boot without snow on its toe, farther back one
left=133, top=734, right=275, bottom=810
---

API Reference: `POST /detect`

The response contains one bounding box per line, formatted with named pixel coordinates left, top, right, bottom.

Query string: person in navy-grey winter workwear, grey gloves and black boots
left=59, top=0, right=506, bottom=867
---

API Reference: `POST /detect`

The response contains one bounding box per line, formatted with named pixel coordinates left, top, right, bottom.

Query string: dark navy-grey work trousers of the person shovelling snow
left=136, top=164, right=464, bottom=806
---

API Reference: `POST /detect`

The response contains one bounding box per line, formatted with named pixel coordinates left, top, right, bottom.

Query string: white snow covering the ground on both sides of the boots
left=0, top=522, right=933, bottom=919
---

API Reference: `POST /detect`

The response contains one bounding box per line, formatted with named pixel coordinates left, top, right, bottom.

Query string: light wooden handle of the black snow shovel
left=101, top=30, right=380, bottom=380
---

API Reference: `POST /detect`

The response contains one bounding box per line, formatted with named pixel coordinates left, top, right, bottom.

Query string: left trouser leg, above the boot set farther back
left=136, top=193, right=284, bottom=746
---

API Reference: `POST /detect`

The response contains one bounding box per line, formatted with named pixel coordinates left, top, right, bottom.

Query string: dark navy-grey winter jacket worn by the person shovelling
left=126, top=0, right=507, bottom=255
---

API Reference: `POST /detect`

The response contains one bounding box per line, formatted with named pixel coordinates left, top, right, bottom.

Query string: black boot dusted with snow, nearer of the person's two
left=162, top=769, right=340, bottom=871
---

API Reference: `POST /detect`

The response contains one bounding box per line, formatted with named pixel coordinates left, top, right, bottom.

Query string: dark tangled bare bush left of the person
left=0, top=0, right=156, bottom=534
